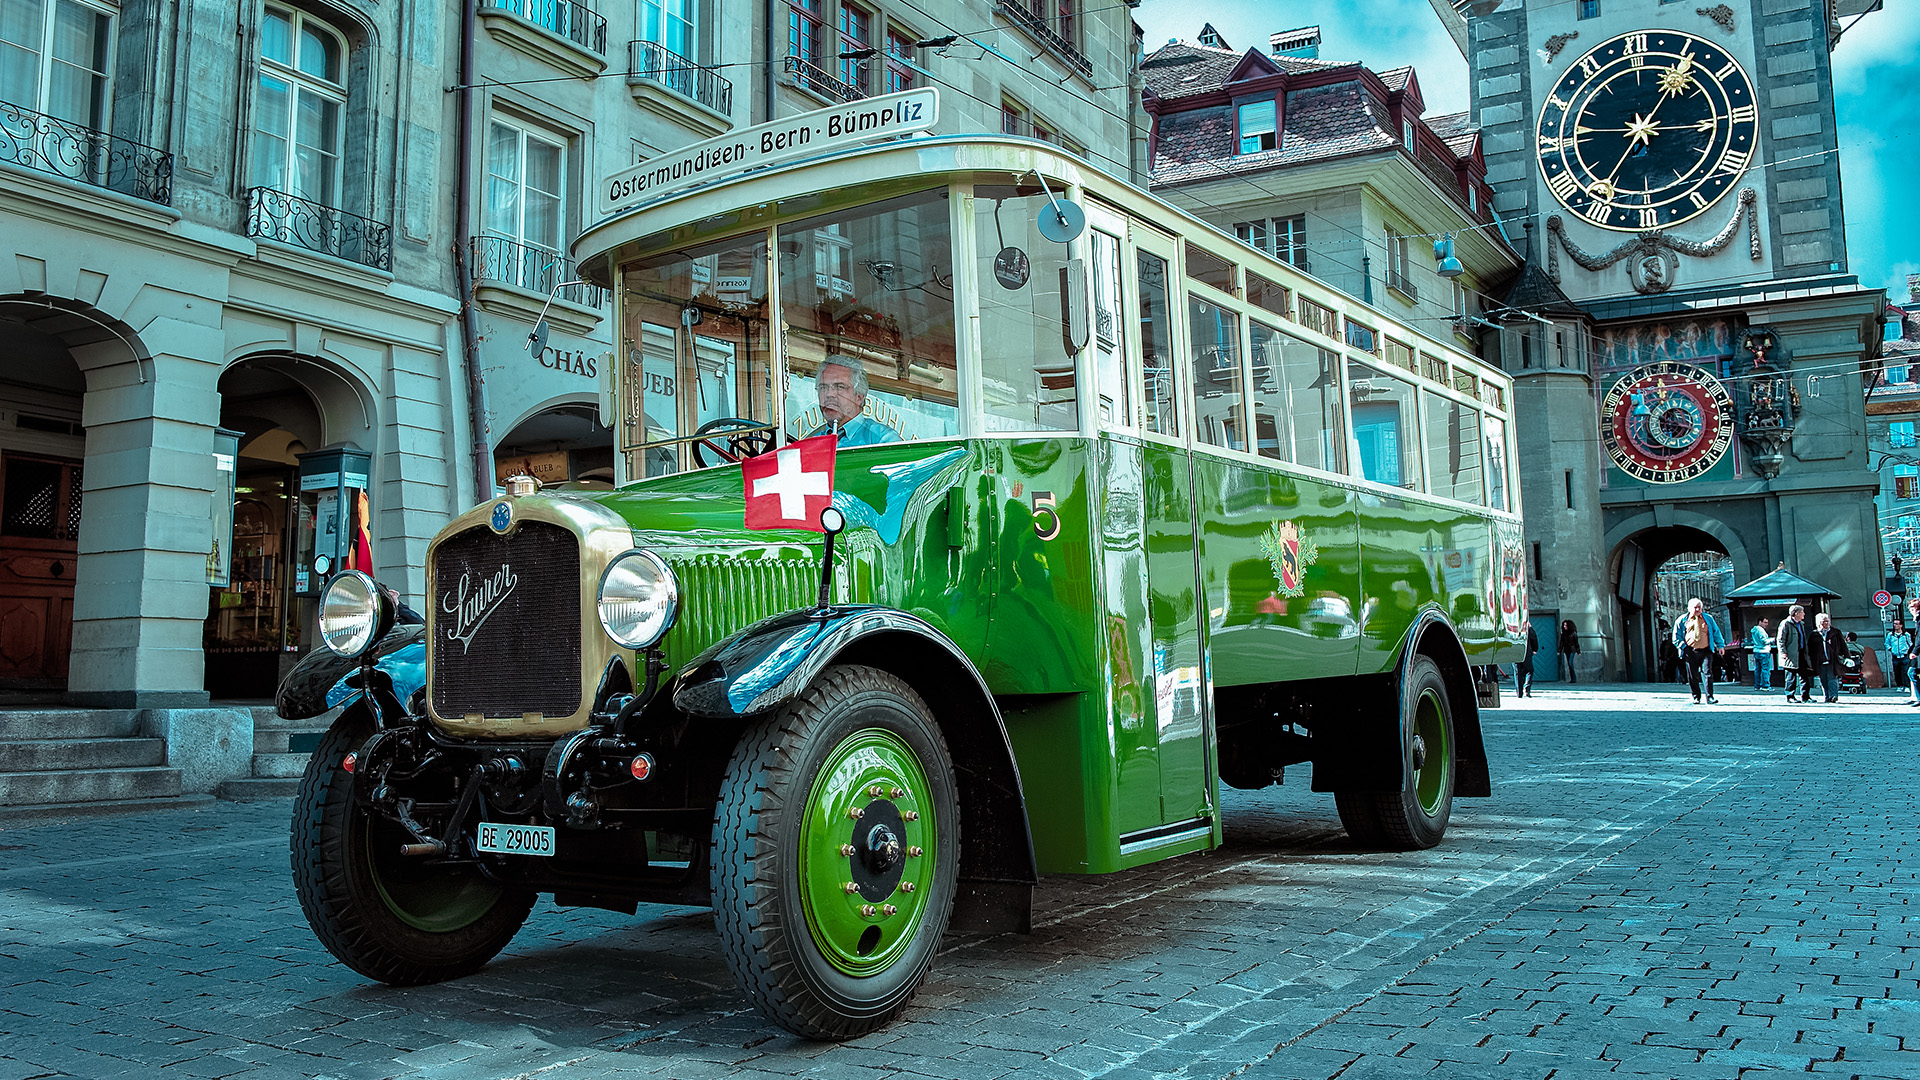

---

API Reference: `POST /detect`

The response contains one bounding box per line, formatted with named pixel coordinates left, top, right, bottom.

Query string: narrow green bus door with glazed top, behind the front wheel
left=1110, top=225, right=1210, bottom=837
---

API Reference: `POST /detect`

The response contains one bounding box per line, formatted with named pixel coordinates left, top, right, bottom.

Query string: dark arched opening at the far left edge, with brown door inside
left=0, top=320, right=86, bottom=692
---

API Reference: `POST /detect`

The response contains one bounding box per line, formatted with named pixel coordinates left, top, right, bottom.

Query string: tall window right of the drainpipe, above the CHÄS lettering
left=480, top=117, right=566, bottom=292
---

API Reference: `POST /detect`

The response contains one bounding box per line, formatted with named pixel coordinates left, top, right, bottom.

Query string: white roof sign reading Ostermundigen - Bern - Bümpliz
left=597, top=86, right=941, bottom=217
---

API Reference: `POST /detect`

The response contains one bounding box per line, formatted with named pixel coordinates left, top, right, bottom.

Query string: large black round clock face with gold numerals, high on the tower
left=1538, top=31, right=1759, bottom=233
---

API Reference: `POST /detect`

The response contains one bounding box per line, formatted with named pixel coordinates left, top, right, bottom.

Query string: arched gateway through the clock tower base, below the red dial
left=1611, top=515, right=1747, bottom=682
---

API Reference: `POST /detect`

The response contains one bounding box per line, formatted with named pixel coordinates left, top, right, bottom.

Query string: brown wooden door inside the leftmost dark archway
left=0, top=454, right=81, bottom=686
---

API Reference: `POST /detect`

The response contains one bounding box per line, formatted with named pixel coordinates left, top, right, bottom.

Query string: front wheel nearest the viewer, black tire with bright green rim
left=712, top=665, right=960, bottom=1040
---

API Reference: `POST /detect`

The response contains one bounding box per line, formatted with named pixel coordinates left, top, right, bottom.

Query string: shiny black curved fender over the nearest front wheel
left=670, top=603, right=1039, bottom=930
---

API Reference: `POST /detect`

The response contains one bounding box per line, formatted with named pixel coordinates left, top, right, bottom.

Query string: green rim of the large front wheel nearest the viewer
left=799, top=728, right=939, bottom=976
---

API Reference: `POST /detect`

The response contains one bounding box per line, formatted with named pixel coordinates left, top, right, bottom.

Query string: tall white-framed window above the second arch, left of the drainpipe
left=253, top=6, right=348, bottom=206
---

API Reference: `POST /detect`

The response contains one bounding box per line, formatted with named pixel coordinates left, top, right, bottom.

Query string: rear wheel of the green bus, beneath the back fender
left=1334, top=655, right=1455, bottom=851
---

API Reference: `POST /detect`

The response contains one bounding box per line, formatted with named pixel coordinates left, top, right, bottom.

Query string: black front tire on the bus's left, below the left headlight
left=292, top=709, right=534, bottom=986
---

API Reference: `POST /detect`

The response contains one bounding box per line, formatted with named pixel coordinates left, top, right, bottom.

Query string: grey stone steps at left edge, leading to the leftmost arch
left=0, top=705, right=205, bottom=821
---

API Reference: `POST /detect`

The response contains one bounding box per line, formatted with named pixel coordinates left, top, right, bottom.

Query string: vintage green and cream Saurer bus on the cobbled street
left=280, top=90, right=1526, bottom=1038
